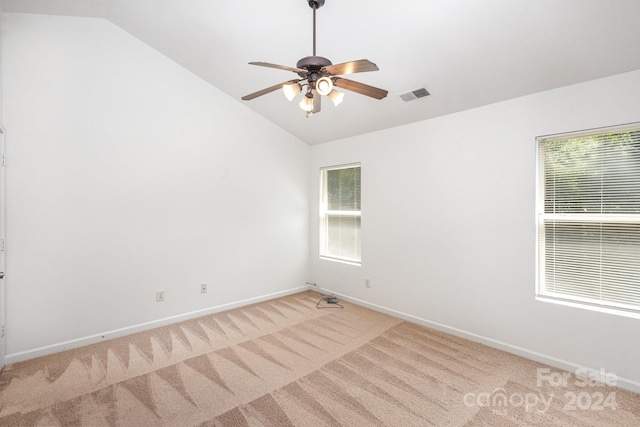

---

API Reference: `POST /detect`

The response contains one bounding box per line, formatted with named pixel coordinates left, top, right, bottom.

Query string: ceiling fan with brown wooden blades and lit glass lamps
left=242, top=0, right=388, bottom=117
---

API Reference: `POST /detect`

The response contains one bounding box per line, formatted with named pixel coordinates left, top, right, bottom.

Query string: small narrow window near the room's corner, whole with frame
left=320, top=165, right=361, bottom=264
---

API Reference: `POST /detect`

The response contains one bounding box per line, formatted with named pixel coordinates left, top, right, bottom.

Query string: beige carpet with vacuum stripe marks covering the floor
left=0, top=292, right=640, bottom=427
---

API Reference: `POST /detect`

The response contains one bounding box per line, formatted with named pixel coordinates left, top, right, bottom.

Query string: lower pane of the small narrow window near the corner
left=326, top=215, right=360, bottom=260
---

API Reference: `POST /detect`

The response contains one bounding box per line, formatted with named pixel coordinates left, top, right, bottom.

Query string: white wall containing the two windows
left=310, top=71, right=640, bottom=391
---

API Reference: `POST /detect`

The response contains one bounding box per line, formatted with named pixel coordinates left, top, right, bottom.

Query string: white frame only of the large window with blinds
left=535, top=122, right=640, bottom=318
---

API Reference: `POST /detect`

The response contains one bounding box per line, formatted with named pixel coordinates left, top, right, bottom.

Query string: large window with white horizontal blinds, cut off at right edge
left=537, top=123, right=640, bottom=313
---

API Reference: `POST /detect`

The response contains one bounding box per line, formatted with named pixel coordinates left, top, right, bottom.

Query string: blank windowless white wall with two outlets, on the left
left=3, top=14, right=310, bottom=362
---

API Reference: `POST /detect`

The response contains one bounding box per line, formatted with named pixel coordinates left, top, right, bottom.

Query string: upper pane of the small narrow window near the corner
left=327, top=167, right=360, bottom=211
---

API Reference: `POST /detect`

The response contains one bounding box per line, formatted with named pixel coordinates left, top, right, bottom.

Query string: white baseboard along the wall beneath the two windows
left=318, top=286, right=640, bottom=394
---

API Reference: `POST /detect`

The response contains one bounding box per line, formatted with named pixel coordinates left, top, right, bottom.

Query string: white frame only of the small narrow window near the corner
left=318, top=162, right=362, bottom=266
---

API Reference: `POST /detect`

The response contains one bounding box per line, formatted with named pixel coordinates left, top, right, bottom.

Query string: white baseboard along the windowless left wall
left=4, top=286, right=308, bottom=365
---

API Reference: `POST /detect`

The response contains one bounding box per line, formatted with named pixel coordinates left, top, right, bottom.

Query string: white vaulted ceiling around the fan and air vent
left=0, top=0, right=640, bottom=144
